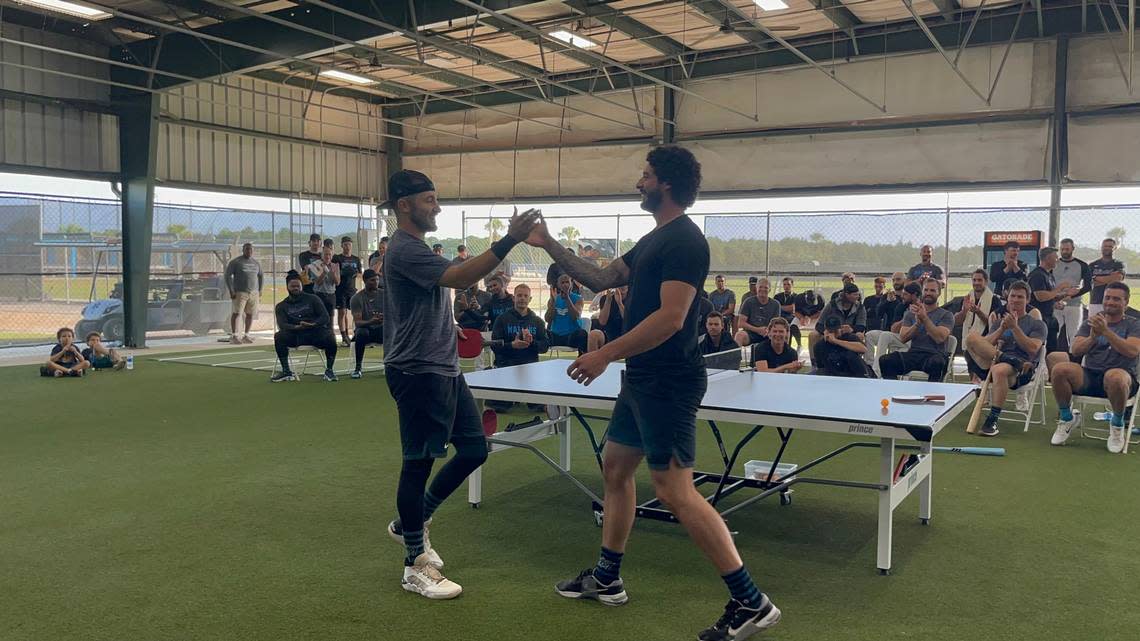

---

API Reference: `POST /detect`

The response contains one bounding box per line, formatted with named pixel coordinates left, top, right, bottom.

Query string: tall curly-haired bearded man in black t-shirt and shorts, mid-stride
left=527, top=146, right=780, bottom=639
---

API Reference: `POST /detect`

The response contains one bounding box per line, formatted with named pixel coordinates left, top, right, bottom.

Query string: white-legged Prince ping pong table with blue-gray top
left=465, top=350, right=978, bottom=575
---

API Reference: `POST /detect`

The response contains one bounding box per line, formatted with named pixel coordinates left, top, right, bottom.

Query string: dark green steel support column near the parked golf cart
left=119, top=94, right=158, bottom=348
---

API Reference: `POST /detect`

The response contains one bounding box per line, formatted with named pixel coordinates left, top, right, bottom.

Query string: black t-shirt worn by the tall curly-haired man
left=621, top=216, right=709, bottom=369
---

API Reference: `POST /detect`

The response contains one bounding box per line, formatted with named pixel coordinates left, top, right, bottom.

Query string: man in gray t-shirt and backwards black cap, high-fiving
left=383, top=170, right=539, bottom=599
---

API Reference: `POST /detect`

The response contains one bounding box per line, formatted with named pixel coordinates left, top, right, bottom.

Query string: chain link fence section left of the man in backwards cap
left=0, top=195, right=378, bottom=347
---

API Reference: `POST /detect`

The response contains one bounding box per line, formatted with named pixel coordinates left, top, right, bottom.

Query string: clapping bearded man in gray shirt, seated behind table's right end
left=879, top=278, right=954, bottom=381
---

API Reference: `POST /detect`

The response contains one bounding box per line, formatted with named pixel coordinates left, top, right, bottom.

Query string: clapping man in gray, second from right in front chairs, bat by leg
left=963, top=279, right=1045, bottom=436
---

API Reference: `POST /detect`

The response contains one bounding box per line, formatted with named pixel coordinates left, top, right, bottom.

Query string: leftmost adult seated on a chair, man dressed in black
left=270, top=271, right=336, bottom=383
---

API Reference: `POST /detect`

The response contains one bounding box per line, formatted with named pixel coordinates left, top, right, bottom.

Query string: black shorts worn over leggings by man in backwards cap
left=384, top=367, right=487, bottom=461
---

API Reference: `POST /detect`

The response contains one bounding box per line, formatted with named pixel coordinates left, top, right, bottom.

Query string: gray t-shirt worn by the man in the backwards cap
left=384, top=229, right=459, bottom=376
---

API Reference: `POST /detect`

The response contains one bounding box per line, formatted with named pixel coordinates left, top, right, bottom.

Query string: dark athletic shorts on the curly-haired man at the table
left=605, top=367, right=708, bottom=470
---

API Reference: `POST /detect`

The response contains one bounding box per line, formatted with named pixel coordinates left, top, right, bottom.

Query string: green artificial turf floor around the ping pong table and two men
left=0, top=357, right=1140, bottom=641
